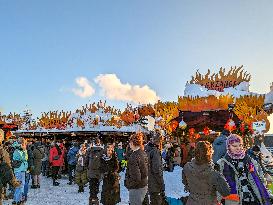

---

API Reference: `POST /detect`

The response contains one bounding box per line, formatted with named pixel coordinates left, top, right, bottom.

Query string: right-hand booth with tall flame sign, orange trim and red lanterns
left=150, top=66, right=273, bottom=167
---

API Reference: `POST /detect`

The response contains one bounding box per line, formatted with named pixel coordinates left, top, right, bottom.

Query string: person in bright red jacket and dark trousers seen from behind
left=49, top=143, right=64, bottom=186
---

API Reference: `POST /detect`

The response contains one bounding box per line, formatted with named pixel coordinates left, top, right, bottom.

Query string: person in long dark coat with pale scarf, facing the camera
left=101, top=145, right=121, bottom=205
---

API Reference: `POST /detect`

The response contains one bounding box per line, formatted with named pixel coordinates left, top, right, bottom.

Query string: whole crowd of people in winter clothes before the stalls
left=0, top=131, right=272, bottom=205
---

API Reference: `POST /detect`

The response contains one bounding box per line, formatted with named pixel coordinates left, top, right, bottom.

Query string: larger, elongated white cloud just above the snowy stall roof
left=95, top=74, right=159, bottom=104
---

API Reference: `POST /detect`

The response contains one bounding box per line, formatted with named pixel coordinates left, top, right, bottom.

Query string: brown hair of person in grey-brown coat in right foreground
left=195, top=141, right=212, bottom=164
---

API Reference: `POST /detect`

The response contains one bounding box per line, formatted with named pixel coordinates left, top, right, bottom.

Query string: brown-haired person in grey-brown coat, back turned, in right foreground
left=182, top=141, right=230, bottom=205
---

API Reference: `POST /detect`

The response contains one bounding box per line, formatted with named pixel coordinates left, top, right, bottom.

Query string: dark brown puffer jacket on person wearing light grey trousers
left=125, top=149, right=148, bottom=189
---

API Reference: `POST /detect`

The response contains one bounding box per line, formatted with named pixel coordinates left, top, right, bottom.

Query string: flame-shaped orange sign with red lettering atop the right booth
left=190, top=66, right=251, bottom=92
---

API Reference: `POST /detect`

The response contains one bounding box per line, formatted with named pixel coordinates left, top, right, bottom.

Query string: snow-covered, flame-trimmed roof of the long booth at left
left=2, top=101, right=149, bottom=142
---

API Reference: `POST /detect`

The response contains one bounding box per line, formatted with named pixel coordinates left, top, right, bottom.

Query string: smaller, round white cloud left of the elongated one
left=72, top=77, right=95, bottom=98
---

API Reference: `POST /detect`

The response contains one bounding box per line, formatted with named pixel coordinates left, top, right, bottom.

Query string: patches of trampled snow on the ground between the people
left=4, top=167, right=186, bottom=205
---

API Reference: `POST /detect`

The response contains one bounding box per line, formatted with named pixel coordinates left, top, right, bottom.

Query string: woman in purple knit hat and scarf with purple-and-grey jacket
left=217, top=134, right=271, bottom=205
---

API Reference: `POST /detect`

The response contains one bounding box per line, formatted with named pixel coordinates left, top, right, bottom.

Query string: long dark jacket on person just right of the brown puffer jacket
left=145, top=142, right=165, bottom=193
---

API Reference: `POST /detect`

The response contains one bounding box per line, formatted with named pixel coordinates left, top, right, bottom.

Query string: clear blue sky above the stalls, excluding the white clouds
left=0, top=0, right=273, bottom=131
